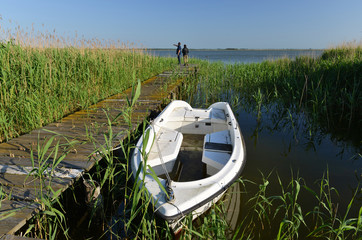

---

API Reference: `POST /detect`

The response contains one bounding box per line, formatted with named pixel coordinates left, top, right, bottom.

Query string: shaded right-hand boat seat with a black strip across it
left=202, top=130, right=233, bottom=175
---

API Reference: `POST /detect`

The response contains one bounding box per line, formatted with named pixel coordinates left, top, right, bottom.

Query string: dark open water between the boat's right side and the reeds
left=236, top=103, right=362, bottom=193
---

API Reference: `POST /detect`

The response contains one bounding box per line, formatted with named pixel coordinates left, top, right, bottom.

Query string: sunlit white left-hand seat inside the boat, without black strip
left=147, top=129, right=183, bottom=176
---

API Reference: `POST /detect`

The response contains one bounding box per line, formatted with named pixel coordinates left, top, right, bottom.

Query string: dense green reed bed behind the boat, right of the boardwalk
left=186, top=45, right=362, bottom=146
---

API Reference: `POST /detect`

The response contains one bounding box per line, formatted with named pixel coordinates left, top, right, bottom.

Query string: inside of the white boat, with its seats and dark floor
left=147, top=108, right=233, bottom=182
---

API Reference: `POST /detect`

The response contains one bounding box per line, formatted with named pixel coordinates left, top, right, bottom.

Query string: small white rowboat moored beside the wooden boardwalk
left=131, top=100, right=246, bottom=231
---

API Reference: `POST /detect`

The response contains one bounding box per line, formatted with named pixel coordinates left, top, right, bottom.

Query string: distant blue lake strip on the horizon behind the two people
left=148, top=49, right=323, bottom=64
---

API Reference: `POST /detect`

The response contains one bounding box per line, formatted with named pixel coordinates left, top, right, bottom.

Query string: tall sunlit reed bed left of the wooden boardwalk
left=0, top=41, right=174, bottom=142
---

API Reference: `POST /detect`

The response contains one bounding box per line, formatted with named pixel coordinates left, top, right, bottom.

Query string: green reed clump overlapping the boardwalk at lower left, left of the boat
left=24, top=135, right=72, bottom=239
